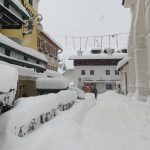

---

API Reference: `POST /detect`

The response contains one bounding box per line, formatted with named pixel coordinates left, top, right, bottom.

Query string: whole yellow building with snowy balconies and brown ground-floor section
left=0, top=0, right=48, bottom=98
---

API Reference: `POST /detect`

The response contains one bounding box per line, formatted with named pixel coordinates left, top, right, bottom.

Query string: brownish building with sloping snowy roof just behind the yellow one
left=37, top=31, right=63, bottom=71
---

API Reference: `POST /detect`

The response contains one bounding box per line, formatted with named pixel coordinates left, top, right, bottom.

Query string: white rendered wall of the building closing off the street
left=74, top=66, right=121, bottom=93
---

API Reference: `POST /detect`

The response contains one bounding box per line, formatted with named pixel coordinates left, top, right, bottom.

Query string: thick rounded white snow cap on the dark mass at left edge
left=0, top=64, right=18, bottom=92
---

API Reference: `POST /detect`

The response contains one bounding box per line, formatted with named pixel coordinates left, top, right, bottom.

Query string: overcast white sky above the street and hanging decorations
left=39, top=0, right=130, bottom=67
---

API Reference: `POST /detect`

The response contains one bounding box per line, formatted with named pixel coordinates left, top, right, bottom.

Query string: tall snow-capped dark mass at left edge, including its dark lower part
left=0, top=64, right=18, bottom=114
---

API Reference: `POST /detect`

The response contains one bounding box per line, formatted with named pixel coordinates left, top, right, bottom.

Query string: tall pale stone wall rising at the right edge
left=122, top=0, right=150, bottom=100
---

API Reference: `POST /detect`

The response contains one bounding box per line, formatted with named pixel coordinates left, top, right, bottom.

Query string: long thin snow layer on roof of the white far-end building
left=69, top=53, right=127, bottom=60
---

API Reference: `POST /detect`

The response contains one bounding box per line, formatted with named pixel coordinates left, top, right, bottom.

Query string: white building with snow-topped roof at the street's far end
left=70, top=53, right=126, bottom=93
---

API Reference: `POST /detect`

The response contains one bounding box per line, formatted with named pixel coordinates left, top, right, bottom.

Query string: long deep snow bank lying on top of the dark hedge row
left=0, top=90, right=77, bottom=134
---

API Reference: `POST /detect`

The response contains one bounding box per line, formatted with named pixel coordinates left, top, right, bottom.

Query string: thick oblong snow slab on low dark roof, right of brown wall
left=36, top=77, right=69, bottom=89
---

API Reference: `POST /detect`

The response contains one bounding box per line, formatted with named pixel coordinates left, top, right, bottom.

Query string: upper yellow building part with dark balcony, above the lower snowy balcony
left=0, top=0, right=39, bottom=50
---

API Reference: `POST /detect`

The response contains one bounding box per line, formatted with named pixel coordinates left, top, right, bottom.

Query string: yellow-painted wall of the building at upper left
left=0, top=0, right=39, bottom=50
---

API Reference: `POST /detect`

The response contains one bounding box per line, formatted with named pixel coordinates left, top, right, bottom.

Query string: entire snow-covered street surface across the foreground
left=0, top=91, right=150, bottom=150
